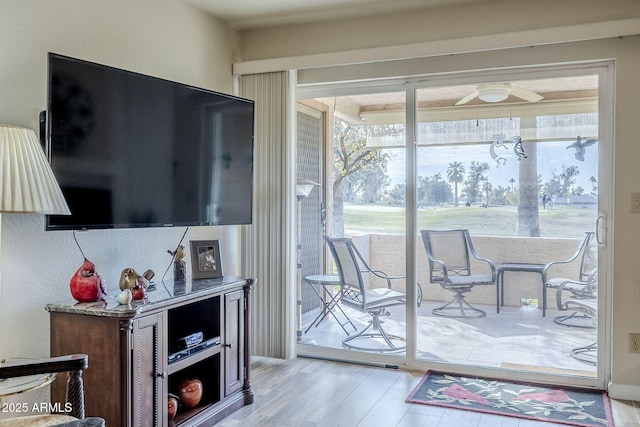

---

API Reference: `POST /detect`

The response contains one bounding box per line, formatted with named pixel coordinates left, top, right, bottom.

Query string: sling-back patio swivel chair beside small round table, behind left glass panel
left=325, top=237, right=406, bottom=352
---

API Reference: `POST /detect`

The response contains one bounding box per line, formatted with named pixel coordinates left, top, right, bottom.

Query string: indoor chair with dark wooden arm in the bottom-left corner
left=0, top=354, right=105, bottom=427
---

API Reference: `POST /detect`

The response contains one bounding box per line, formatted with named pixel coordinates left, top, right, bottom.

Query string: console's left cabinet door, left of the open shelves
left=130, top=313, right=166, bottom=427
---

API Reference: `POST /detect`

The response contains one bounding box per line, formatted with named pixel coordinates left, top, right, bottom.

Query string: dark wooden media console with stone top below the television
left=46, top=277, right=254, bottom=427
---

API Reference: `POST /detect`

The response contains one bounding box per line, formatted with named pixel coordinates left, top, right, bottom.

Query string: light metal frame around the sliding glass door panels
left=296, top=60, right=615, bottom=389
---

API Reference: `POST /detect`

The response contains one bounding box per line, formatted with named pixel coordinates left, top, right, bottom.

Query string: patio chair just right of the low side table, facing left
left=542, top=231, right=598, bottom=328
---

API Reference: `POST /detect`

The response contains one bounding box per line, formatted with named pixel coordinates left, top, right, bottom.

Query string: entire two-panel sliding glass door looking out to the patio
left=299, top=62, right=611, bottom=384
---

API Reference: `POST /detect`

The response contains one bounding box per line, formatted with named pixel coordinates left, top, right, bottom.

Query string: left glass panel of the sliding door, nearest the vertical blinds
left=298, top=90, right=407, bottom=363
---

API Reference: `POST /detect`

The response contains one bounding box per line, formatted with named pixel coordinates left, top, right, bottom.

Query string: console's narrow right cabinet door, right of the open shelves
left=224, top=290, right=245, bottom=397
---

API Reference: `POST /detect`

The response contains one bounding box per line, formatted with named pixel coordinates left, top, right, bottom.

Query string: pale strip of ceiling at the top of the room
left=184, top=0, right=483, bottom=30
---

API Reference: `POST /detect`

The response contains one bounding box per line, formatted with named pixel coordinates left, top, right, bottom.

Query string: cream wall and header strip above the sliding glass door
left=234, top=0, right=640, bottom=74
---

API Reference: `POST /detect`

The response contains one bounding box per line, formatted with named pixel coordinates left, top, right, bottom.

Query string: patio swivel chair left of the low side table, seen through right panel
left=420, top=230, right=496, bottom=317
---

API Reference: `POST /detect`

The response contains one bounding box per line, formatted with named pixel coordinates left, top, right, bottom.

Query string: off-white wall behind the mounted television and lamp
left=0, top=0, right=242, bottom=363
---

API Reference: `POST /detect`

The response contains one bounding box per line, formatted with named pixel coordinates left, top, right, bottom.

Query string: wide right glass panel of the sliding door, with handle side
left=416, top=74, right=600, bottom=378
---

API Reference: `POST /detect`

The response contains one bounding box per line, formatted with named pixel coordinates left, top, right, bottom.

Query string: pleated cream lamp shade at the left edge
left=0, top=125, right=71, bottom=215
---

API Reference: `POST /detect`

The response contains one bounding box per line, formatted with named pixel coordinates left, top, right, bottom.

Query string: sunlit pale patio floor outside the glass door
left=301, top=301, right=596, bottom=376
